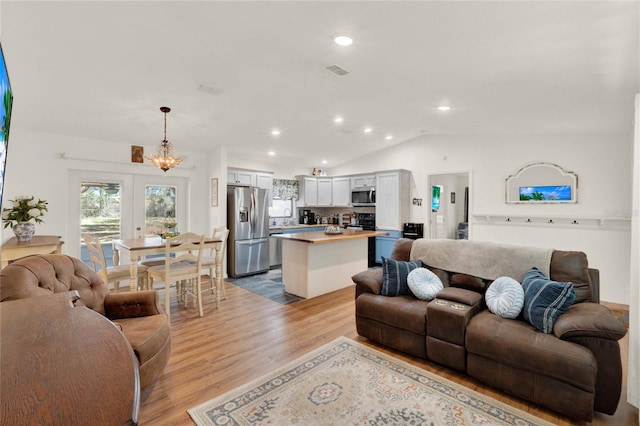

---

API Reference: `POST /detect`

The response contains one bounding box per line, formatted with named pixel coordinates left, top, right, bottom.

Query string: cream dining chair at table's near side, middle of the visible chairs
left=147, top=232, right=204, bottom=316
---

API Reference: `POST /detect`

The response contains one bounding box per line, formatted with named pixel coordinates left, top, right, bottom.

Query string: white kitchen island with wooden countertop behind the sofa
left=273, top=229, right=387, bottom=299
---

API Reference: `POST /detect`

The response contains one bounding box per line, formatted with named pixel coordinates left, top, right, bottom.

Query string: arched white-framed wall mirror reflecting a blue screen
left=505, top=162, right=578, bottom=204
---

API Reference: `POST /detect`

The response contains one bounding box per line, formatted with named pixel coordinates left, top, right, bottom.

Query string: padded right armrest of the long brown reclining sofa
left=553, top=302, right=627, bottom=341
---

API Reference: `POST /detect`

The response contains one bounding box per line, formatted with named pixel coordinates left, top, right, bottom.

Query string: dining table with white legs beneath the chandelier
left=112, top=236, right=223, bottom=307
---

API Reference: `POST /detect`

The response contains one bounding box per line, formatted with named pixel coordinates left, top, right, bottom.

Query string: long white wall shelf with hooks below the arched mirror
left=472, top=214, right=631, bottom=229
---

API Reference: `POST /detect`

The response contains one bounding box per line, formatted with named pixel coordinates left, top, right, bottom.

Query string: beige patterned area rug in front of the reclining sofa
left=188, top=337, right=550, bottom=426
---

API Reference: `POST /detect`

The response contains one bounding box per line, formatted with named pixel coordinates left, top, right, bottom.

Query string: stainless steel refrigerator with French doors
left=227, top=186, right=269, bottom=278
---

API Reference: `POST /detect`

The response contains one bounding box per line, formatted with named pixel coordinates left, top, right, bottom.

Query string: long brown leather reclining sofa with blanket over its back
left=352, top=239, right=626, bottom=421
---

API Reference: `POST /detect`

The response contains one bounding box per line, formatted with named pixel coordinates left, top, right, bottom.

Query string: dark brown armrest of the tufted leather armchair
left=104, top=290, right=164, bottom=320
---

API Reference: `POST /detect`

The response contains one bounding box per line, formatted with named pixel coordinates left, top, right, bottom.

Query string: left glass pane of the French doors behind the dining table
left=80, top=182, right=121, bottom=266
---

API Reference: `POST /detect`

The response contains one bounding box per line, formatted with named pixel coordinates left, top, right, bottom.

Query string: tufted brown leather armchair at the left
left=0, top=254, right=171, bottom=389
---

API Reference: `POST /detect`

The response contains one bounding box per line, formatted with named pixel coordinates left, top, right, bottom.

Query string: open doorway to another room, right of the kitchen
left=426, top=171, right=471, bottom=240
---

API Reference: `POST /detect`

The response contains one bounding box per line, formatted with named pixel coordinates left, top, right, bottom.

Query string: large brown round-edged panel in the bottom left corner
left=0, top=291, right=140, bottom=426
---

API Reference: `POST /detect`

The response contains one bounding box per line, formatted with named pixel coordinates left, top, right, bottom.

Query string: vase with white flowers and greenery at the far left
left=2, top=196, right=49, bottom=241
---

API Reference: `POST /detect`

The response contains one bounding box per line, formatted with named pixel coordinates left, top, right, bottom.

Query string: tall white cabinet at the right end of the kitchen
left=376, top=170, right=410, bottom=231
